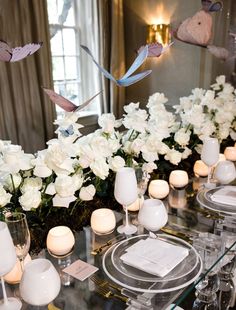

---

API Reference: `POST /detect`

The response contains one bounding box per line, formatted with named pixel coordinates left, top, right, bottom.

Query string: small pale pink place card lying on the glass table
left=62, top=259, right=98, bottom=281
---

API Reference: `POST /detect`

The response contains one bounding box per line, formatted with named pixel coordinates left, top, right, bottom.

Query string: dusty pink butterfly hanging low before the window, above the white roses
left=43, top=87, right=102, bottom=112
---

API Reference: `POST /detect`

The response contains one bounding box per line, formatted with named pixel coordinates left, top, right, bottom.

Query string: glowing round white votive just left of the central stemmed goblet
left=91, top=208, right=116, bottom=235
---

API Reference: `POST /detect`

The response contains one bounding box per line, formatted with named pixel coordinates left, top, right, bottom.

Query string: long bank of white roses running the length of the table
left=0, top=76, right=236, bottom=217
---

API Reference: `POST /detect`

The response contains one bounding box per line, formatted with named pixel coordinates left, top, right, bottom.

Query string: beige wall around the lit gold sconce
left=124, top=0, right=233, bottom=109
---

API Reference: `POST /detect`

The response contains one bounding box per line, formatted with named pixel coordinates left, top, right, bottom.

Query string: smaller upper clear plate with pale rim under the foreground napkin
left=111, top=234, right=198, bottom=282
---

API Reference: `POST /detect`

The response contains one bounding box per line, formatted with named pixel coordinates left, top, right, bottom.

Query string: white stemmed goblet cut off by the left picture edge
left=0, top=222, right=22, bottom=310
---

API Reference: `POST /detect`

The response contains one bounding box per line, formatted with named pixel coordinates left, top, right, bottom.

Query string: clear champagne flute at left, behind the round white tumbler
left=5, top=212, right=30, bottom=272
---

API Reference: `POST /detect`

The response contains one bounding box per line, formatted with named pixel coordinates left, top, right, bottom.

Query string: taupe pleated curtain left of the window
left=0, top=0, right=56, bottom=152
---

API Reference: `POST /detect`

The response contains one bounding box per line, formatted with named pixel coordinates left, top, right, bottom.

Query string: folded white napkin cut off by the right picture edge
left=210, top=186, right=236, bottom=207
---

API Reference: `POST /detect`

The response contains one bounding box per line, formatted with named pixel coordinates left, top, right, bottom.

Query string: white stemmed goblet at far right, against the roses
left=201, top=137, right=220, bottom=185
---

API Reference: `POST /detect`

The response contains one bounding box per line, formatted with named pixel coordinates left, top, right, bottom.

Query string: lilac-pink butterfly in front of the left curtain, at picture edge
left=0, top=40, right=43, bottom=62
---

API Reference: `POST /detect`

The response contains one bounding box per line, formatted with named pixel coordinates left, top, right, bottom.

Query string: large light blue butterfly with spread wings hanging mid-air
left=81, top=45, right=152, bottom=86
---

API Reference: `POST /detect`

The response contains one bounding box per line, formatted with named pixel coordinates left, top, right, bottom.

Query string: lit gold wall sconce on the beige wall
left=147, top=24, right=170, bottom=46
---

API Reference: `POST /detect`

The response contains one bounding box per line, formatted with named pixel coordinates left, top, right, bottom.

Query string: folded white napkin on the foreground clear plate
left=120, top=238, right=189, bottom=277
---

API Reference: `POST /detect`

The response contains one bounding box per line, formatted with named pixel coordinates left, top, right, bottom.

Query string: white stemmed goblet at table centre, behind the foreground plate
left=114, top=167, right=138, bottom=235
